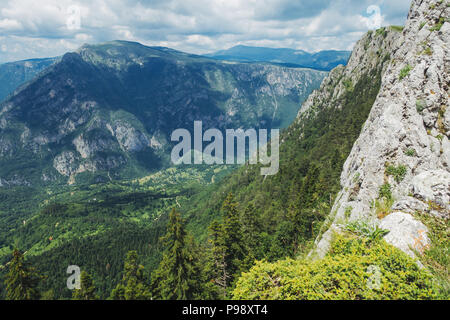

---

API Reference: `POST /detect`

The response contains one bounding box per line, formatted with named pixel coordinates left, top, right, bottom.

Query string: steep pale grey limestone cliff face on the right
left=307, top=0, right=450, bottom=256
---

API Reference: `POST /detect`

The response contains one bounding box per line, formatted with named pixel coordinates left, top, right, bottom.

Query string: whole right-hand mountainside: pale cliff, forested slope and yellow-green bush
left=178, top=0, right=450, bottom=300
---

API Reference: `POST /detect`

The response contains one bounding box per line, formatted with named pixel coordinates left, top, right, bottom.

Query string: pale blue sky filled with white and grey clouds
left=0, top=0, right=411, bottom=63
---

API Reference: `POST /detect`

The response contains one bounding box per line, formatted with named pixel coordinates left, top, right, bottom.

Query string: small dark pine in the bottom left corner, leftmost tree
left=5, top=249, right=42, bottom=300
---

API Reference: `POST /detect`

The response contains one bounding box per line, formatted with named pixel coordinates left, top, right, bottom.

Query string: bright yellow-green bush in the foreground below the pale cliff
left=233, top=236, right=437, bottom=300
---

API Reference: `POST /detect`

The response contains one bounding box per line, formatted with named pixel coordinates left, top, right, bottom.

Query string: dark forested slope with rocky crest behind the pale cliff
left=182, top=29, right=400, bottom=254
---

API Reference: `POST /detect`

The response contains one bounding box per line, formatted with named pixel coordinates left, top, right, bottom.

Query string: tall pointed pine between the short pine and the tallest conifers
left=152, top=209, right=202, bottom=300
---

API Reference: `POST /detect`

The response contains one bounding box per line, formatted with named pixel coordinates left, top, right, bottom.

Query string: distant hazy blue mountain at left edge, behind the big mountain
left=0, top=58, right=58, bottom=101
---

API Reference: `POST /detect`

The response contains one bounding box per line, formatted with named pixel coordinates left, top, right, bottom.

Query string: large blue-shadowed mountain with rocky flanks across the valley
left=0, top=41, right=326, bottom=187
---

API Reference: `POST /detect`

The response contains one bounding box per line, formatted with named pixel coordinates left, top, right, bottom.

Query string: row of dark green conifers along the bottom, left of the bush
left=4, top=193, right=268, bottom=300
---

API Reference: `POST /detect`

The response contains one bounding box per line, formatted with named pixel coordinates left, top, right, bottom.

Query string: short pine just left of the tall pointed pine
left=110, top=251, right=152, bottom=300
